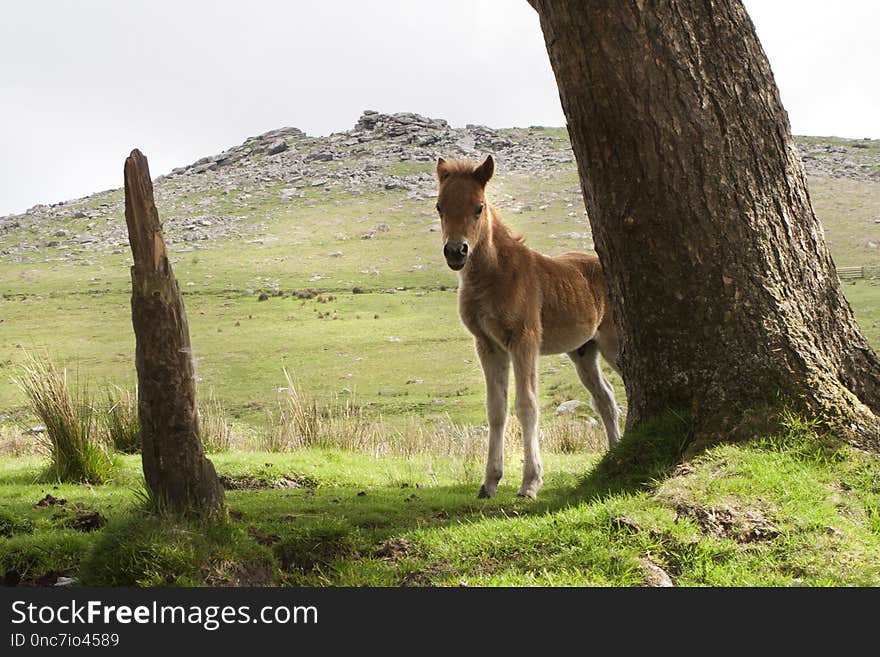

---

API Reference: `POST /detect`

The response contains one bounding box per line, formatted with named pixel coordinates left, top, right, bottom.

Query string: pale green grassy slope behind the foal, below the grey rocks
left=0, top=167, right=880, bottom=430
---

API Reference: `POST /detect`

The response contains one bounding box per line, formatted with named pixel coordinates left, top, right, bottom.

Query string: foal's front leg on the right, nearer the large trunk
left=511, top=342, right=544, bottom=500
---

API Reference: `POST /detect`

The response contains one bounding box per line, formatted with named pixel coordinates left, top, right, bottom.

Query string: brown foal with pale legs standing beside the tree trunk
left=437, top=155, right=620, bottom=499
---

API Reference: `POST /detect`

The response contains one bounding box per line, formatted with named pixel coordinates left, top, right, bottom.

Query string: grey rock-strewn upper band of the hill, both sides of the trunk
left=0, top=110, right=880, bottom=264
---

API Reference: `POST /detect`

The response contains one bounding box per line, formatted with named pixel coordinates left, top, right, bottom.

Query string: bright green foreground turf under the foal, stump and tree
left=0, top=420, right=880, bottom=586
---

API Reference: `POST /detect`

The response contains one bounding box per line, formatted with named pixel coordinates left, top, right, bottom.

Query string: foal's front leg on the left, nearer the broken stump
left=476, top=338, right=510, bottom=497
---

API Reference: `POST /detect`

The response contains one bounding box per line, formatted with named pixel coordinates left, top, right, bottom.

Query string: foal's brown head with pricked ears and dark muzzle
left=437, top=155, right=495, bottom=271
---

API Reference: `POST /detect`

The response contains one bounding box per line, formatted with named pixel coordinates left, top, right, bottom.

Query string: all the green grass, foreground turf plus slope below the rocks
left=0, top=137, right=880, bottom=586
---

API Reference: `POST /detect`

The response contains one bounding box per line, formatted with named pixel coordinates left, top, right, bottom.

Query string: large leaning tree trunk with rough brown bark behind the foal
left=530, top=0, right=880, bottom=449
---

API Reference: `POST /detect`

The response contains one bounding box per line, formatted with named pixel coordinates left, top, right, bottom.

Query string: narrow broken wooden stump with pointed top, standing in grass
left=125, top=150, right=224, bottom=511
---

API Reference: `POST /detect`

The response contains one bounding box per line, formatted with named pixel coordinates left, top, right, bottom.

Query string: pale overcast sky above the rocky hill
left=0, top=0, right=880, bottom=216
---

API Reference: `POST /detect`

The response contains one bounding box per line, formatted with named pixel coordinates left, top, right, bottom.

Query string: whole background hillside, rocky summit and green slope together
left=0, top=111, right=880, bottom=426
